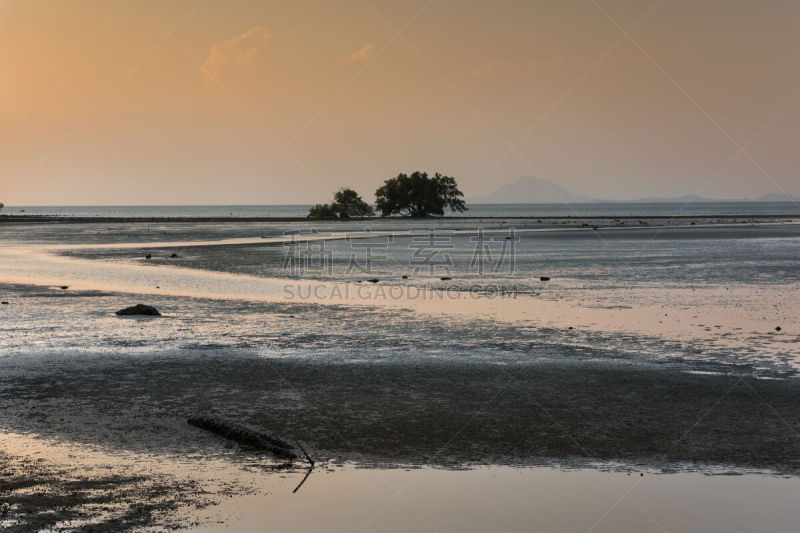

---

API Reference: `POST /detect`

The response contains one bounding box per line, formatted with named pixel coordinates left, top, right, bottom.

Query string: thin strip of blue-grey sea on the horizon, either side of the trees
left=0, top=202, right=800, bottom=218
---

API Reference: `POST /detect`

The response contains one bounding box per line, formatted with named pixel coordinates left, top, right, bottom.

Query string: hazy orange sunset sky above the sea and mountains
left=0, top=0, right=800, bottom=205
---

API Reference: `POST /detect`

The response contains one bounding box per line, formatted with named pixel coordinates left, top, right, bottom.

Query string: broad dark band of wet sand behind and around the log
left=0, top=354, right=800, bottom=474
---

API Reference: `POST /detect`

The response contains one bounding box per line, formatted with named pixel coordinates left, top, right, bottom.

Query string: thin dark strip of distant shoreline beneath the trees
left=0, top=213, right=800, bottom=224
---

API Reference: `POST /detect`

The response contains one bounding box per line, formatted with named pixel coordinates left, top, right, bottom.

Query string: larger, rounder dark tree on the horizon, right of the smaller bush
left=375, top=171, right=467, bottom=217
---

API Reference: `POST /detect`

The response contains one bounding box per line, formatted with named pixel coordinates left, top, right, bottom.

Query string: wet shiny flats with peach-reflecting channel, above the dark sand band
left=0, top=220, right=800, bottom=376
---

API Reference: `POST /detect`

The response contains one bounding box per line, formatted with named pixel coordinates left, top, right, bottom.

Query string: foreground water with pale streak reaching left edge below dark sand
left=0, top=428, right=800, bottom=533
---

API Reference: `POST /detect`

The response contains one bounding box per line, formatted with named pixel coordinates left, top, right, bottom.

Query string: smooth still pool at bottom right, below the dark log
left=191, top=467, right=800, bottom=533
